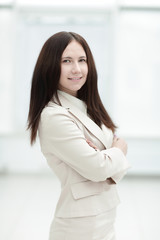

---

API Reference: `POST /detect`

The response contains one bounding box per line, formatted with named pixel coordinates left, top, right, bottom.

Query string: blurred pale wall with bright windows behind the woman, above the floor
left=0, top=1, right=160, bottom=174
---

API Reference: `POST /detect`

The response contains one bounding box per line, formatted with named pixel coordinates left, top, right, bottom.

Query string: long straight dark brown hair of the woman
left=27, top=32, right=116, bottom=144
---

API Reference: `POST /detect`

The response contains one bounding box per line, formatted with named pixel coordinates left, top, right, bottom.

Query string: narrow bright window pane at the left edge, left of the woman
left=0, top=9, right=14, bottom=133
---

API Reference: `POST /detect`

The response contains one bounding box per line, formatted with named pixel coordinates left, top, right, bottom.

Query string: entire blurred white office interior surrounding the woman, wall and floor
left=0, top=0, right=160, bottom=240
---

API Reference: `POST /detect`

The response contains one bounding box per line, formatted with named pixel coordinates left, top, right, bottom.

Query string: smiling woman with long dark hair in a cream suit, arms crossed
left=28, top=32, right=129, bottom=240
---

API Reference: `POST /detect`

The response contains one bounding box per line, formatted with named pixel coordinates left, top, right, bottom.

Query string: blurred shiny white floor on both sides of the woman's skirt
left=0, top=175, right=160, bottom=240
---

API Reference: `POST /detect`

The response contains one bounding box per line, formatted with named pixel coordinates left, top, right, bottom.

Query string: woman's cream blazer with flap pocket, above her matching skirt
left=38, top=91, right=129, bottom=218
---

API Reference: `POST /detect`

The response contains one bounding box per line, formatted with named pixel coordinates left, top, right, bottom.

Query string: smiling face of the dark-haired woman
left=59, top=40, right=88, bottom=96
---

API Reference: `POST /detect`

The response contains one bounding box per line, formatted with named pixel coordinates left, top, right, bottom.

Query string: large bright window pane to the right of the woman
left=115, top=11, right=160, bottom=136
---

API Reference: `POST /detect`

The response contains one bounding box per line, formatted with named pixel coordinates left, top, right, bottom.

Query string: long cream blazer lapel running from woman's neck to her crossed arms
left=59, top=92, right=107, bottom=148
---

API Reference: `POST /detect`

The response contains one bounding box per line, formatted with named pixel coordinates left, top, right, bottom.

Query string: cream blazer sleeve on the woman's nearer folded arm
left=39, top=107, right=129, bottom=182
